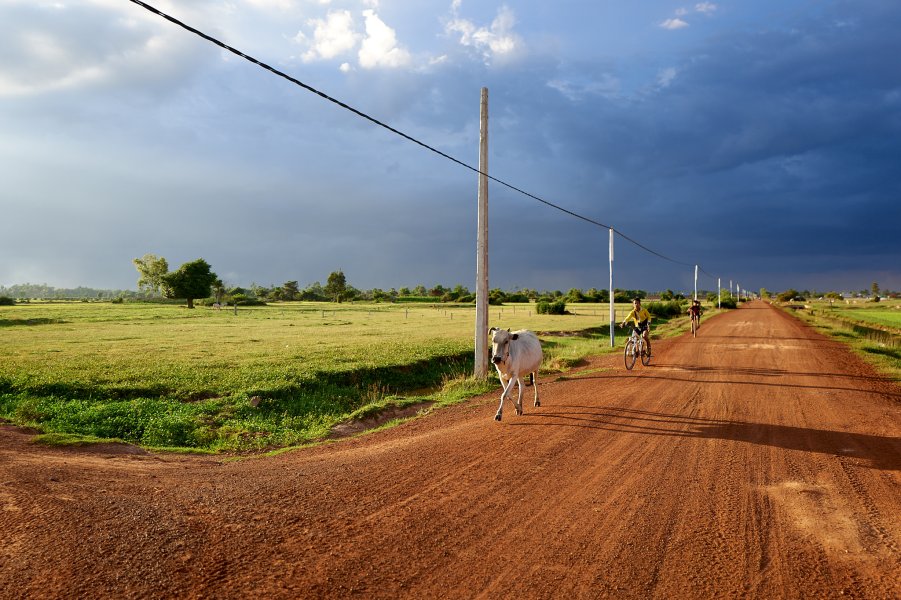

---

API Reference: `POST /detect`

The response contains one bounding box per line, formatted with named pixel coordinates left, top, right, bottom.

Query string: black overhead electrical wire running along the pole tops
left=125, top=0, right=713, bottom=277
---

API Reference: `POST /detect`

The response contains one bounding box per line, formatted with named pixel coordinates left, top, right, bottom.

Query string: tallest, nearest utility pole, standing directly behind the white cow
left=473, top=88, right=488, bottom=378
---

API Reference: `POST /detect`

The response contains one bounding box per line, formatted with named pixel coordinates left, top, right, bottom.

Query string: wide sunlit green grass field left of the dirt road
left=0, top=302, right=678, bottom=451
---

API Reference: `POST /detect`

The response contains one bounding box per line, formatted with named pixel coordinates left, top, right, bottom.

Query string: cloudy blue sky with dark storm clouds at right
left=0, top=0, right=901, bottom=291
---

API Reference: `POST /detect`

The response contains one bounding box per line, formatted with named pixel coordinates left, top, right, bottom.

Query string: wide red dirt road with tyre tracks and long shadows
left=0, top=302, right=901, bottom=599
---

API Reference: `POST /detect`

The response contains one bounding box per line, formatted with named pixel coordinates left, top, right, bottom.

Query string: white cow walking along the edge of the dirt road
left=488, top=327, right=544, bottom=421
